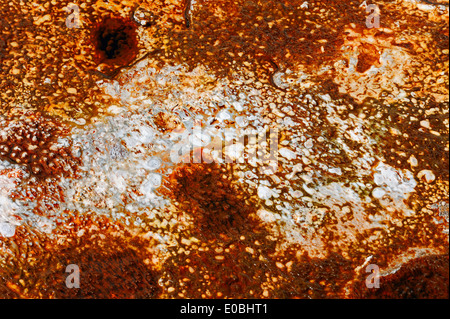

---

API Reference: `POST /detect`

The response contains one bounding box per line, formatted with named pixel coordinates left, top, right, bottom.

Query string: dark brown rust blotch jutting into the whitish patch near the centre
left=164, top=164, right=258, bottom=237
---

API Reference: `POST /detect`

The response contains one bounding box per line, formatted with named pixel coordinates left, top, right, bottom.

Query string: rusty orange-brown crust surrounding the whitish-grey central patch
left=0, top=0, right=449, bottom=298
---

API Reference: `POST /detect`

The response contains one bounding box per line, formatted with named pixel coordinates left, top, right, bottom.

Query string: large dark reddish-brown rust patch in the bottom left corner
left=0, top=216, right=161, bottom=299
